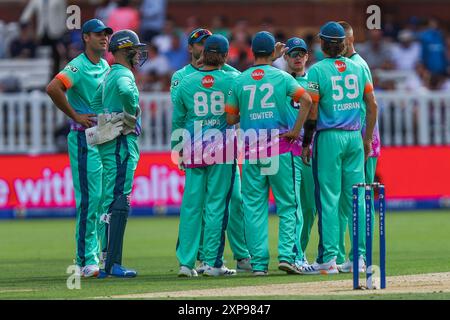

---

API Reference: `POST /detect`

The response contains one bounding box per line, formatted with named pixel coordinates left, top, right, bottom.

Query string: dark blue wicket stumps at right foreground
left=352, top=183, right=386, bottom=289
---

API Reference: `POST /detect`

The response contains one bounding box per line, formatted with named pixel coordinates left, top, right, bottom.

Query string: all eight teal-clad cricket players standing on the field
left=47, top=19, right=380, bottom=278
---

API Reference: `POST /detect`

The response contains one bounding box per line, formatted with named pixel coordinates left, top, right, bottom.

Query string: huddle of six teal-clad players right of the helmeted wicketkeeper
left=171, top=21, right=380, bottom=277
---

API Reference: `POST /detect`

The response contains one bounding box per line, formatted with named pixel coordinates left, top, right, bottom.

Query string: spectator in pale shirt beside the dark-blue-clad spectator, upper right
left=392, top=29, right=420, bottom=71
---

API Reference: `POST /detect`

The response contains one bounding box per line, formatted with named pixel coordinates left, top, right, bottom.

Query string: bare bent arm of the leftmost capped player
left=46, top=78, right=95, bottom=128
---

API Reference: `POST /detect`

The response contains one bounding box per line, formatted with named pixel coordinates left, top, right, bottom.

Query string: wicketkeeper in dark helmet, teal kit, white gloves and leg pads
left=86, top=29, right=147, bottom=278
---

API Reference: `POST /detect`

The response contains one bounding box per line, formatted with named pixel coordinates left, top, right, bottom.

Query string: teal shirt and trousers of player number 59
left=308, top=57, right=373, bottom=263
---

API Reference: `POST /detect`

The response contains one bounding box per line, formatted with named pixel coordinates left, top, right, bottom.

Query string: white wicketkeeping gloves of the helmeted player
left=85, top=114, right=123, bottom=146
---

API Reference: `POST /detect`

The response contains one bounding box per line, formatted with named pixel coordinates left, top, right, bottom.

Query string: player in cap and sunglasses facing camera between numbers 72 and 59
left=284, top=37, right=316, bottom=267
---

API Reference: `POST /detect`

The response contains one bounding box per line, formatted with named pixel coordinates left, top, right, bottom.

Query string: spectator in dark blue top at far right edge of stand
left=419, top=18, right=447, bottom=74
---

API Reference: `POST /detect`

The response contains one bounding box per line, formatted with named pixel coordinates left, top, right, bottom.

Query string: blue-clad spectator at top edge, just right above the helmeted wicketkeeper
left=140, top=0, right=167, bottom=43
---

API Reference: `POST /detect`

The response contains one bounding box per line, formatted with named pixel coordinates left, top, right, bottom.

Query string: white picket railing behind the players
left=0, top=91, right=450, bottom=154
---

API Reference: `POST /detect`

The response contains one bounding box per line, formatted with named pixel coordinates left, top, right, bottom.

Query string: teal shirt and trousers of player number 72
left=226, top=65, right=305, bottom=271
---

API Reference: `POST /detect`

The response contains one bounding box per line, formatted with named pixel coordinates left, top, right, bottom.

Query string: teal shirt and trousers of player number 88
left=172, top=69, right=244, bottom=268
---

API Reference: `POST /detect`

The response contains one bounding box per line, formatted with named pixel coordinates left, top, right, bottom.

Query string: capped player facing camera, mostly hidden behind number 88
left=170, top=28, right=251, bottom=273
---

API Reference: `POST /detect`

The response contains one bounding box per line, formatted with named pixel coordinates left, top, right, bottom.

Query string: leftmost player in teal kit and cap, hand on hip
left=47, top=19, right=113, bottom=277
